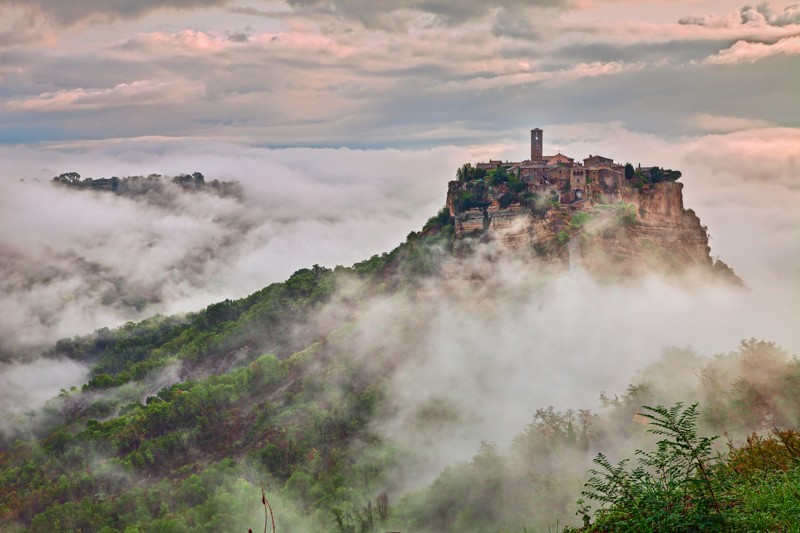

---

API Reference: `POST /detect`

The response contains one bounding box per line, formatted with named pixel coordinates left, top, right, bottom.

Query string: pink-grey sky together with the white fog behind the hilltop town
left=0, top=0, right=800, bottom=356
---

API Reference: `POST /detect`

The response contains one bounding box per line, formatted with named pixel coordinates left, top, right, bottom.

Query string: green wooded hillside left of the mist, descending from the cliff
left=0, top=200, right=468, bottom=531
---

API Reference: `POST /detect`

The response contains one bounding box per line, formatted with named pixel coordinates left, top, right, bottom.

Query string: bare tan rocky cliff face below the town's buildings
left=447, top=182, right=735, bottom=279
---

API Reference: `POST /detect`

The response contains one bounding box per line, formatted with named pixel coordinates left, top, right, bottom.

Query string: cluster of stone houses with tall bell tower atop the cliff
left=477, top=128, right=625, bottom=204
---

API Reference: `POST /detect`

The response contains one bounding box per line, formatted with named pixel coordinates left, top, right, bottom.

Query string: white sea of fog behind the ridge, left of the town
left=0, top=141, right=472, bottom=350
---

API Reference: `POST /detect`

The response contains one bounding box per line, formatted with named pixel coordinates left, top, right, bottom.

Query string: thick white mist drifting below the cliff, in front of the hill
left=302, top=237, right=800, bottom=492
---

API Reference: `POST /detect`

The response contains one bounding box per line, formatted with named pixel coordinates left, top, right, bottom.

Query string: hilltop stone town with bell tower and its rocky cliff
left=446, top=128, right=732, bottom=279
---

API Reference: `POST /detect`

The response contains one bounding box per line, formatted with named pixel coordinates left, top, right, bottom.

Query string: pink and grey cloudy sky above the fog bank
left=0, top=0, right=800, bottom=148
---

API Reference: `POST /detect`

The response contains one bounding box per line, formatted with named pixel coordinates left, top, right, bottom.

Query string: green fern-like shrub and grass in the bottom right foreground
left=570, top=403, right=800, bottom=532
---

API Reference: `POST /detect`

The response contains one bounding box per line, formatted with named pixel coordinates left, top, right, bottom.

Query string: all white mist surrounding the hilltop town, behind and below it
left=0, top=125, right=800, bottom=491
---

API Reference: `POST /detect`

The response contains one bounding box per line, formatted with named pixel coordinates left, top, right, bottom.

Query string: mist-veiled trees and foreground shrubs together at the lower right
left=397, top=339, right=800, bottom=532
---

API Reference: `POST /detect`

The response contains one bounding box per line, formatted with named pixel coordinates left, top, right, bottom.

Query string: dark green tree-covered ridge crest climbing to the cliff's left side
left=42, top=208, right=454, bottom=390
